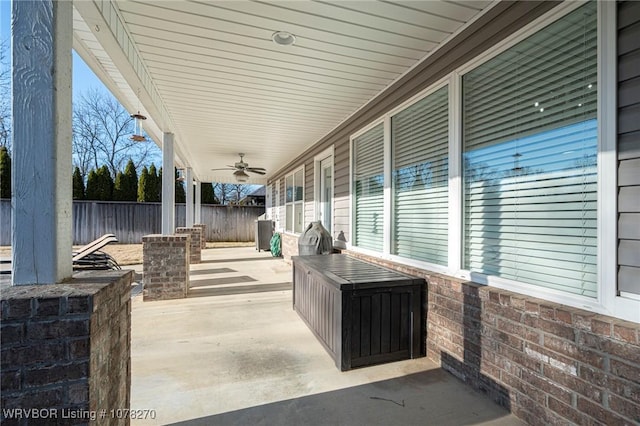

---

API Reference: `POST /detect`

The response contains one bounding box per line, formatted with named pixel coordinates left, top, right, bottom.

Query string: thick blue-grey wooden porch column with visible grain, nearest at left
left=11, top=1, right=73, bottom=285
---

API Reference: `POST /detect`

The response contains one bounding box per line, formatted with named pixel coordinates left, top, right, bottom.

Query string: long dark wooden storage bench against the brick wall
left=292, top=254, right=426, bottom=371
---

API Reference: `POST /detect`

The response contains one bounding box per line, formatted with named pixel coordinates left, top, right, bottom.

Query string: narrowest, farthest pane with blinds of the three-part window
left=353, top=124, right=384, bottom=252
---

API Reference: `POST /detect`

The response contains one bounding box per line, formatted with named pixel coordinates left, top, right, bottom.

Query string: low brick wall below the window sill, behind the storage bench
left=349, top=253, right=640, bottom=425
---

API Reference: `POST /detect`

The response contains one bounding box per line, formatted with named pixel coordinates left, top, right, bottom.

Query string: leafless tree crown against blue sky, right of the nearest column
left=73, top=89, right=160, bottom=179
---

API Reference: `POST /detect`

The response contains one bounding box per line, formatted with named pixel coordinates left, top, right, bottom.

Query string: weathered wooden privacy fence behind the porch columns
left=0, top=199, right=264, bottom=246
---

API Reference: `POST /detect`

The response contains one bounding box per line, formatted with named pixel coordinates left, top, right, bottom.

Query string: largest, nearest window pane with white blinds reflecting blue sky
left=462, top=2, right=598, bottom=297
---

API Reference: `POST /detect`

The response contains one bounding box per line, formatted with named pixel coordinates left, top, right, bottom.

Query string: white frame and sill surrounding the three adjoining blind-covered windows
left=347, top=1, right=640, bottom=323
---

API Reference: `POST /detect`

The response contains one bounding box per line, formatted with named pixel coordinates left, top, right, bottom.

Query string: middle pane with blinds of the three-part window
left=391, top=87, right=449, bottom=266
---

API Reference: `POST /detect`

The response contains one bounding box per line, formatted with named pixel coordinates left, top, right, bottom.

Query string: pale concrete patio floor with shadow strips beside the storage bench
left=131, top=247, right=523, bottom=425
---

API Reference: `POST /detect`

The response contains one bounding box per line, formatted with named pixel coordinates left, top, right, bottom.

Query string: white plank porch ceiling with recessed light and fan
left=74, top=0, right=493, bottom=184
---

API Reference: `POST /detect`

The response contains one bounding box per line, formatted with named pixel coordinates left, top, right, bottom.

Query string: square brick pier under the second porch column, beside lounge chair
left=142, top=234, right=189, bottom=302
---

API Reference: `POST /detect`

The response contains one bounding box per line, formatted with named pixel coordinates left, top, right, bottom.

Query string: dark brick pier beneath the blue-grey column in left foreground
left=0, top=271, right=133, bottom=425
